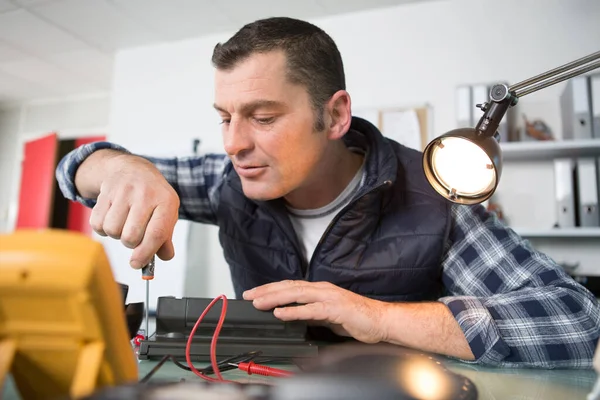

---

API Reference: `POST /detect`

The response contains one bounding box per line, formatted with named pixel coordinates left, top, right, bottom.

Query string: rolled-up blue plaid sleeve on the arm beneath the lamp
left=439, top=205, right=600, bottom=368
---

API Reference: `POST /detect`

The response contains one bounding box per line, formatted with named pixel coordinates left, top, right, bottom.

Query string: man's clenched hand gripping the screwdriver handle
left=83, top=152, right=179, bottom=269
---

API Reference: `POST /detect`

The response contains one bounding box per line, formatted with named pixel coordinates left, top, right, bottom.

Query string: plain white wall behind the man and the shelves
left=110, top=0, right=600, bottom=296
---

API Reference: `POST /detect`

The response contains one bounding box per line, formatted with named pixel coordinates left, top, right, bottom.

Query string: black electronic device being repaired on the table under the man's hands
left=138, top=297, right=318, bottom=361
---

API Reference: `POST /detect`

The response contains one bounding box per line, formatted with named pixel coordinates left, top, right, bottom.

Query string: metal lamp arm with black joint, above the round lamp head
left=475, top=51, right=600, bottom=136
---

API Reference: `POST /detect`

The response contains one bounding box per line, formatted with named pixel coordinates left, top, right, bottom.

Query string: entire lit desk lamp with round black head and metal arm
left=423, top=51, right=600, bottom=204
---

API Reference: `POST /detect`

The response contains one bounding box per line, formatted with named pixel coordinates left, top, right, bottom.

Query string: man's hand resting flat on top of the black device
left=244, top=280, right=386, bottom=343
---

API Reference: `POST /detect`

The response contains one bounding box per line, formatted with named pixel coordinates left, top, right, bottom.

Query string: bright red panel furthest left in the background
left=15, top=133, right=58, bottom=229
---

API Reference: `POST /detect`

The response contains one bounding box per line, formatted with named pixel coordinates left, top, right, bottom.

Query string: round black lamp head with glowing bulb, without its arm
left=423, top=128, right=502, bottom=204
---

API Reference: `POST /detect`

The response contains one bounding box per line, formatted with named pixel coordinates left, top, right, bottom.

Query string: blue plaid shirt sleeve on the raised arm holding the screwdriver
left=56, top=142, right=229, bottom=224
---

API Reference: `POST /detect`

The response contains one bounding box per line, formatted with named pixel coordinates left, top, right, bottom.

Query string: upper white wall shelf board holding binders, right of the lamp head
left=500, top=139, right=600, bottom=161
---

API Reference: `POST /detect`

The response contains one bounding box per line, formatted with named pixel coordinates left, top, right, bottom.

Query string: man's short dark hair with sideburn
left=212, top=17, right=346, bottom=131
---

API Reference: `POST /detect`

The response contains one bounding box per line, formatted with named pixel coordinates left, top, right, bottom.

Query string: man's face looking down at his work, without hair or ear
left=215, top=52, right=328, bottom=200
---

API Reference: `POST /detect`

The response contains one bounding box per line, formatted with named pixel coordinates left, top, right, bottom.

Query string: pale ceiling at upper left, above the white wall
left=0, top=0, right=418, bottom=104
